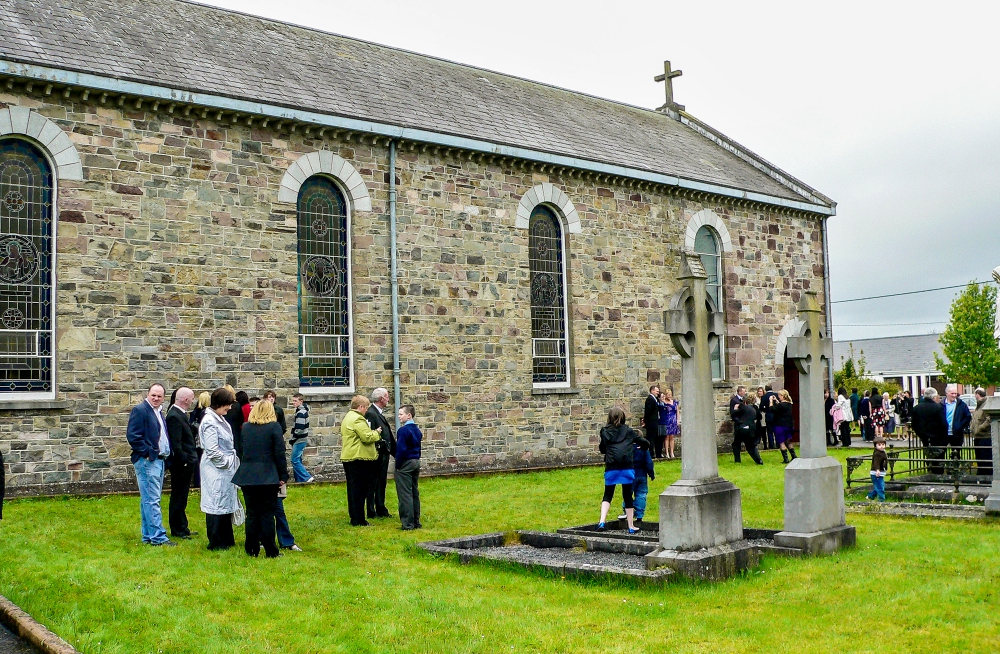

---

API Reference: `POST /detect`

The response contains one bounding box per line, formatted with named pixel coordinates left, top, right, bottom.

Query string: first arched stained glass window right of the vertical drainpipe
left=528, top=205, right=569, bottom=386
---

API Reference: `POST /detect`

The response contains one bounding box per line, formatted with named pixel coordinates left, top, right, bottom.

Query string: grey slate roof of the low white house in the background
left=833, top=334, right=948, bottom=375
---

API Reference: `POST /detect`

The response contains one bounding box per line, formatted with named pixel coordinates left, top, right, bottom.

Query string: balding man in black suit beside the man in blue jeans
left=166, top=386, right=198, bottom=539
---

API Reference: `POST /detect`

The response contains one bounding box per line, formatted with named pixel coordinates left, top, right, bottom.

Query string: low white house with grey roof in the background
left=833, top=334, right=948, bottom=397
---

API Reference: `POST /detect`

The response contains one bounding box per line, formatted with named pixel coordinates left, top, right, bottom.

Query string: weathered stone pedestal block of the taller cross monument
left=660, top=477, right=743, bottom=552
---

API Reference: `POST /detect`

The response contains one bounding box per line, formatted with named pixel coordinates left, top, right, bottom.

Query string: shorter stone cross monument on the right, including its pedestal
left=774, top=292, right=855, bottom=554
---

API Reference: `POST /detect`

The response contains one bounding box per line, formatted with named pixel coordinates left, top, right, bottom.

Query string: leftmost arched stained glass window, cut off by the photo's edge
left=0, top=139, right=55, bottom=395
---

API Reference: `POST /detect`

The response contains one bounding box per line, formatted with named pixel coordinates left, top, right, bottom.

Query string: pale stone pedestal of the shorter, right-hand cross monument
left=774, top=456, right=856, bottom=554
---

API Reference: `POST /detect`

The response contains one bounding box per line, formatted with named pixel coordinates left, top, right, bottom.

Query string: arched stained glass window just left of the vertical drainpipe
left=298, top=176, right=352, bottom=387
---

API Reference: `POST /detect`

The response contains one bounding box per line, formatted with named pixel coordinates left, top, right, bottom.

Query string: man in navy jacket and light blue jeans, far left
left=125, top=384, right=177, bottom=545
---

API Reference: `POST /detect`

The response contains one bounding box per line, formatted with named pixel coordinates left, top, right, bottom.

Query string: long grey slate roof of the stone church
left=0, top=0, right=828, bottom=208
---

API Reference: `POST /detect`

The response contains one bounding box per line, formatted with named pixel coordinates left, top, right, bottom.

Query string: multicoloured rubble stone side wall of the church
left=0, top=90, right=823, bottom=492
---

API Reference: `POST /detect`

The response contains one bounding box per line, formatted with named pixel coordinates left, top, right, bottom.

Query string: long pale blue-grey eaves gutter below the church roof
left=0, top=59, right=836, bottom=216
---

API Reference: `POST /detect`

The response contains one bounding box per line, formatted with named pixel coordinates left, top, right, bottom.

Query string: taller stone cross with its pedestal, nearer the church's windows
left=660, top=251, right=744, bottom=551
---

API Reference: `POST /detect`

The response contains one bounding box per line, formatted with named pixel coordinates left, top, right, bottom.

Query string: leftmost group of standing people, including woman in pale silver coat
left=126, top=384, right=307, bottom=557
